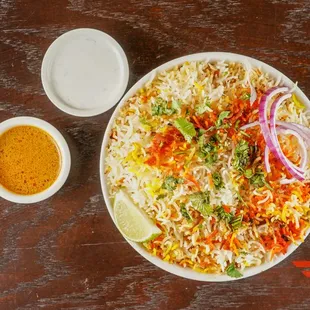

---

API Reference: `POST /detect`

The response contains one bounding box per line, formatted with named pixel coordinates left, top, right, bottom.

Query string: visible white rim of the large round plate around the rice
left=100, top=52, right=309, bottom=282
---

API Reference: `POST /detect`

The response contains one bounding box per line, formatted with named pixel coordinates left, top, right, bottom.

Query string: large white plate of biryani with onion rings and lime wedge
left=100, top=52, right=310, bottom=281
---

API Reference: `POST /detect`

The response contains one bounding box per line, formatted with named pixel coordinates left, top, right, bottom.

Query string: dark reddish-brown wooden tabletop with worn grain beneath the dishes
left=0, top=0, right=310, bottom=309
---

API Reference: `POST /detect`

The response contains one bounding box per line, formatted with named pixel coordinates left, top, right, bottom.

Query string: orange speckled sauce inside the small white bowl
left=0, top=126, right=61, bottom=195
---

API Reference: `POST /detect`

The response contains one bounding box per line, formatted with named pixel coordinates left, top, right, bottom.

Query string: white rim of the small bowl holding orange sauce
left=0, top=117, right=71, bottom=204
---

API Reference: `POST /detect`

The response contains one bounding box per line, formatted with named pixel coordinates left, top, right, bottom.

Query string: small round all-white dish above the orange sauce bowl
left=41, top=28, right=129, bottom=117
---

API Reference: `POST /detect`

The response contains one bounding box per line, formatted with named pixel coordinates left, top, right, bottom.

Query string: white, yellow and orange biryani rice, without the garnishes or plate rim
left=105, top=61, right=310, bottom=273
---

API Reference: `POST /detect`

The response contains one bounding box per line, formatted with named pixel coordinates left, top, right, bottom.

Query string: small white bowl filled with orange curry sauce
left=0, top=117, right=71, bottom=203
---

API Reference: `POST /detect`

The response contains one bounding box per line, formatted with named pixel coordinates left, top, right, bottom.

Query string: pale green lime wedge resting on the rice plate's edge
left=114, top=190, right=161, bottom=242
